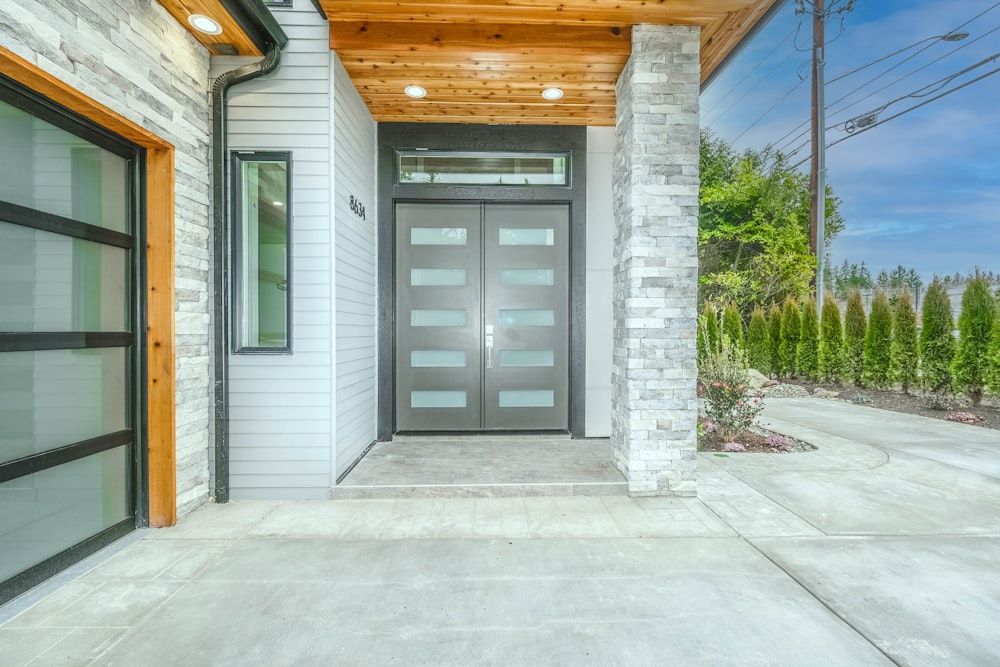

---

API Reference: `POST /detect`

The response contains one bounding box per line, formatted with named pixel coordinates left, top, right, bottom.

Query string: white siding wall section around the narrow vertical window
left=228, top=0, right=333, bottom=499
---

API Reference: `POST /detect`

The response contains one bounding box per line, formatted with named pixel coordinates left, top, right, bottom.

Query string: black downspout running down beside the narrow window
left=212, top=42, right=284, bottom=503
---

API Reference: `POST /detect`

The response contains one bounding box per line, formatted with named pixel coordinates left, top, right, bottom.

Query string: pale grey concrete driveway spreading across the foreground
left=0, top=399, right=1000, bottom=667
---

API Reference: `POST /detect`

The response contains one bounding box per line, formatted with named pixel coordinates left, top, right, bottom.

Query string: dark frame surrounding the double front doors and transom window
left=376, top=123, right=587, bottom=441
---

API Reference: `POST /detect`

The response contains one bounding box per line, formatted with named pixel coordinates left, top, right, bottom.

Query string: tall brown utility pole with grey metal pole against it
left=809, top=0, right=826, bottom=314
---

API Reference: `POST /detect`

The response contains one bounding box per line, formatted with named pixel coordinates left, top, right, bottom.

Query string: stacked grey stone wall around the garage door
left=0, top=0, right=211, bottom=514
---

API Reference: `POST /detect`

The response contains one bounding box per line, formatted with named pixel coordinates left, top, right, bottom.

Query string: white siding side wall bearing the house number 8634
left=331, top=53, right=377, bottom=475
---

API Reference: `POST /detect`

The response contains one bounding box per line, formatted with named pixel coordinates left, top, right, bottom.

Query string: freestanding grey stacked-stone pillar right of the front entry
left=611, top=25, right=700, bottom=496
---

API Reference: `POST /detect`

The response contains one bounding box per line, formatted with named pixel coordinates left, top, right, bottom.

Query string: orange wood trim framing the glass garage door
left=0, top=46, right=177, bottom=527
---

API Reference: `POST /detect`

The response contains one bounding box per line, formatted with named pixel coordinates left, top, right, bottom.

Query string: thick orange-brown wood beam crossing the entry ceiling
left=330, top=21, right=632, bottom=58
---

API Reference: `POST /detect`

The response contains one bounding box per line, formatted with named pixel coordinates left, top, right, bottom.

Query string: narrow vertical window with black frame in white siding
left=232, top=153, right=291, bottom=353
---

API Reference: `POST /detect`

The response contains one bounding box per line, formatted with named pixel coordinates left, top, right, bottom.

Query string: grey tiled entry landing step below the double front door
left=330, top=434, right=628, bottom=499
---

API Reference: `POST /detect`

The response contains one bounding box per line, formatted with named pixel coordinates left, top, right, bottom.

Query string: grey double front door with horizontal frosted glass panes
left=395, top=202, right=569, bottom=431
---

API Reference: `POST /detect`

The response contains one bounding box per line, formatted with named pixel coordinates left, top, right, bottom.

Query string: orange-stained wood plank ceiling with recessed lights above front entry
left=319, top=0, right=775, bottom=125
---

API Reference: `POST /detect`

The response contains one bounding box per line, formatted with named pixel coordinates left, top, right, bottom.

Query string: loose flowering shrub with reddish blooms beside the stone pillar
left=698, top=337, right=764, bottom=436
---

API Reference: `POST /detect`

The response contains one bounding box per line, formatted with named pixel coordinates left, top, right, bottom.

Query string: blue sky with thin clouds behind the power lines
left=701, top=0, right=1000, bottom=279
